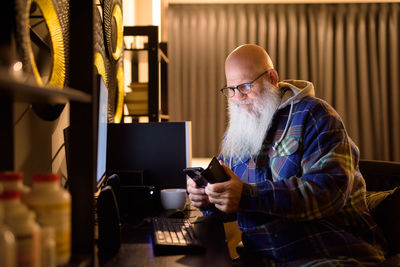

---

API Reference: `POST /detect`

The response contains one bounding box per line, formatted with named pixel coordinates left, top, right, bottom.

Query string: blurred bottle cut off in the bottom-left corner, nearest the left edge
left=0, top=184, right=17, bottom=267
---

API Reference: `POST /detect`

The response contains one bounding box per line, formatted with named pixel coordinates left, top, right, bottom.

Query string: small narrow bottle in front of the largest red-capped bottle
left=41, top=226, right=57, bottom=267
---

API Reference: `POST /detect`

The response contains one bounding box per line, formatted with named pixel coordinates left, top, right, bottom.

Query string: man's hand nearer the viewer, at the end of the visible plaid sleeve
left=205, top=164, right=243, bottom=213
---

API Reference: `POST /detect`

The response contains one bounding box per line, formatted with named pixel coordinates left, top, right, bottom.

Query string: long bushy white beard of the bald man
left=222, top=82, right=281, bottom=159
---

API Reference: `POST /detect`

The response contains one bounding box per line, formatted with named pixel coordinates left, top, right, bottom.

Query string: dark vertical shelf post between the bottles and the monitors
left=68, top=0, right=97, bottom=266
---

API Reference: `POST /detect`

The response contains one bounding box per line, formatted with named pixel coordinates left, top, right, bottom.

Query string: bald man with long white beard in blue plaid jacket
left=188, top=44, right=386, bottom=266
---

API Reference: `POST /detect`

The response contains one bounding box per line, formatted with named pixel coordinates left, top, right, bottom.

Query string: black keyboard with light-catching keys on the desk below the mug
left=152, top=217, right=205, bottom=255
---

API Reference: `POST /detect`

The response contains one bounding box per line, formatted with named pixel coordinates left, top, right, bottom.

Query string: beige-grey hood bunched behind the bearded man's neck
left=278, top=80, right=315, bottom=109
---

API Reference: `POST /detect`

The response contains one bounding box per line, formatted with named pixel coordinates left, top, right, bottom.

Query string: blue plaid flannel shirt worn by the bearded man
left=212, top=80, right=386, bottom=264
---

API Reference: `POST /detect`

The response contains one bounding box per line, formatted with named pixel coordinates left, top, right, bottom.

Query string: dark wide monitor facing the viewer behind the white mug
left=107, top=122, right=191, bottom=190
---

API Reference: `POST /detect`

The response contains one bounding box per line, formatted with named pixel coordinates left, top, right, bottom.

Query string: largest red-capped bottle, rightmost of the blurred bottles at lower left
left=25, top=173, right=71, bottom=265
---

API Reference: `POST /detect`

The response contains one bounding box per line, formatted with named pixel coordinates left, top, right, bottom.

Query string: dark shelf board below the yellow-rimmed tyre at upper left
left=0, top=73, right=92, bottom=104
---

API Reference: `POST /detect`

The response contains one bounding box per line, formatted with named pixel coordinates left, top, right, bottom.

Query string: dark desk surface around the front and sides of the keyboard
left=101, top=217, right=238, bottom=267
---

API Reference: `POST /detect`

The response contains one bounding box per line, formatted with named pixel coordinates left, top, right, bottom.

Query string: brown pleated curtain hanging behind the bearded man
left=168, top=3, right=400, bottom=161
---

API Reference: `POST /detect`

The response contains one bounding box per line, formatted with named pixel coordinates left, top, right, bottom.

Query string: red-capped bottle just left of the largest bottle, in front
left=0, top=191, right=40, bottom=267
